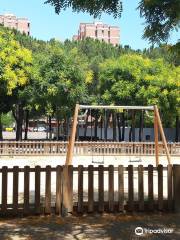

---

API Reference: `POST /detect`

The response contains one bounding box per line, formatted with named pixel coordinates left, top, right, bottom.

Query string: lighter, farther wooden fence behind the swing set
left=0, top=141, right=180, bottom=156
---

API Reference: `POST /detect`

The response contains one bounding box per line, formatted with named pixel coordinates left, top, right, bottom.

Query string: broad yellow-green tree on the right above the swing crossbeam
left=99, top=54, right=180, bottom=141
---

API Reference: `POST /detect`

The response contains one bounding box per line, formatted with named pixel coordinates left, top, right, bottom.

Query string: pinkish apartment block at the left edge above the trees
left=0, top=14, right=30, bottom=35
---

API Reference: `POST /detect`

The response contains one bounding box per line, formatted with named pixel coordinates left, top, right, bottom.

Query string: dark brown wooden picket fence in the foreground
left=0, top=165, right=180, bottom=216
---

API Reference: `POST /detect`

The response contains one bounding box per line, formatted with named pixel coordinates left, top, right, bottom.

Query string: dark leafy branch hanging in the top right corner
left=139, top=0, right=180, bottom=43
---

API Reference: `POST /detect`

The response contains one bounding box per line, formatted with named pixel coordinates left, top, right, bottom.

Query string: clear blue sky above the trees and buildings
left=0, top=0, right=180, bottom=49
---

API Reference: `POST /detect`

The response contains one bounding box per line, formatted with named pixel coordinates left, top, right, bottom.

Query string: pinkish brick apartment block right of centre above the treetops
left=73, top=22, right=120, bottom=46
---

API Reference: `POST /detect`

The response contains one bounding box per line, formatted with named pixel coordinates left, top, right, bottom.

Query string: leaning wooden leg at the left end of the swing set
left=66, top=104, right=79, bottom=165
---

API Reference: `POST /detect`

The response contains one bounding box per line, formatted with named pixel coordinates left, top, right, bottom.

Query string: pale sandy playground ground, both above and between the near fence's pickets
left=0, top=156, right=180, bottom=204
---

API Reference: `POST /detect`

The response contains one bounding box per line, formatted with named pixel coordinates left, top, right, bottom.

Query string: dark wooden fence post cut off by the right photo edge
left=173, top=164, right=180, bottom=212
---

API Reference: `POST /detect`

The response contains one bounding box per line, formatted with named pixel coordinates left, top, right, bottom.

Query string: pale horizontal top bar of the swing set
left=79, top=105, right=154, bottom=111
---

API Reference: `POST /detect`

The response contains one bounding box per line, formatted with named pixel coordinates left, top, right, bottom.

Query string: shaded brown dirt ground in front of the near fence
left=0, top=213, right=180, bottom=240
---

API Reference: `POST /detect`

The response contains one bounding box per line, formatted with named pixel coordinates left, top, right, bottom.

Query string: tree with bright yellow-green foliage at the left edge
left=0, top=29, right=32, bottom=141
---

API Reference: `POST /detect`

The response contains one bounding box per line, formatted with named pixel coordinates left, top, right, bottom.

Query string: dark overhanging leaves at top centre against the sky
left=45, top=0, right=122, bottom=17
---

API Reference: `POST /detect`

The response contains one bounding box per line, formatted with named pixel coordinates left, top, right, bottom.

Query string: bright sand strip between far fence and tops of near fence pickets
left=0, top=155, right=180, bottom=167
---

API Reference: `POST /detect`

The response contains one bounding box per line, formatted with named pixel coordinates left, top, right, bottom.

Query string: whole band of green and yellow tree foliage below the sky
left=0, top=27, right=180, bottom=140
